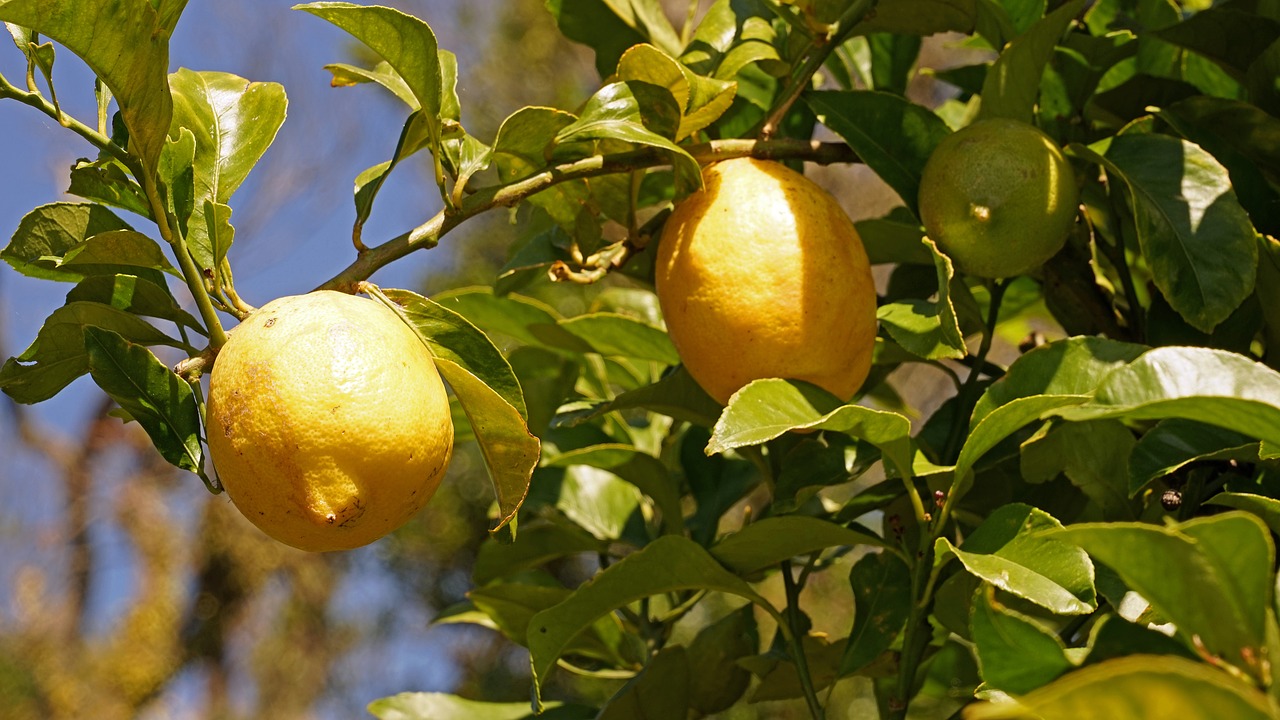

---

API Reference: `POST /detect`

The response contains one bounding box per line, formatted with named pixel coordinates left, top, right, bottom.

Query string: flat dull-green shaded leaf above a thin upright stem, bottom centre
left=710, top=515, right=887, bottom=575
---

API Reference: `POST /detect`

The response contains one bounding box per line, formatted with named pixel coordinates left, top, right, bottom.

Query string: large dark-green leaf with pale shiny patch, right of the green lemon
left=1073, top=133, right=1258, bottom=333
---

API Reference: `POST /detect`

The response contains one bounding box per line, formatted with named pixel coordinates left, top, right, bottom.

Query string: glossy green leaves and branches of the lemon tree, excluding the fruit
left=0, top=0, right=1280, bottom=717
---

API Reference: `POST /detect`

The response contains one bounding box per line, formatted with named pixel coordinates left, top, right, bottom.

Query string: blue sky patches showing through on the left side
left=0, top=0, right=499, bottom=712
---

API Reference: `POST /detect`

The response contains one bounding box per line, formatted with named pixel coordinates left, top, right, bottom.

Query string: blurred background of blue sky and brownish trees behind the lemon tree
left=0, top=0, right=967, bottom=720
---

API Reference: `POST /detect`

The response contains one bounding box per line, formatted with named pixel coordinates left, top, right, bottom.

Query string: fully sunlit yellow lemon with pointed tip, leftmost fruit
left=206, top=291, right=453, bottom=551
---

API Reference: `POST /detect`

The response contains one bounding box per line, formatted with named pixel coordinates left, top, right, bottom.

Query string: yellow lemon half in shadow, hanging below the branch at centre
left=655, top=158, right=876, bottom=402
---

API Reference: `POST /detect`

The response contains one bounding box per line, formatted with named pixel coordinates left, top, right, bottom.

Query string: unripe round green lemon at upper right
left=919, top=118, right=1078, bottom=278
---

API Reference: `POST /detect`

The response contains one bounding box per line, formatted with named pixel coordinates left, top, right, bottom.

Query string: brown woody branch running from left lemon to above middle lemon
left=316, top=138, right=859, bottom=292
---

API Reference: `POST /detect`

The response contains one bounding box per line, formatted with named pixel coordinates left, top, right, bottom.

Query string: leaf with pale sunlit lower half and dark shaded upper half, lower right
left=936, top=502, right=1097, bottom=615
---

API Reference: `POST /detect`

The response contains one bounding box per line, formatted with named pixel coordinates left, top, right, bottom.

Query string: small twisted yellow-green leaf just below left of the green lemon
left=876, top=238, right=968, bottom=360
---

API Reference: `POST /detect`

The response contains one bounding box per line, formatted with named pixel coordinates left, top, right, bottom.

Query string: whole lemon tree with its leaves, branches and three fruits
left=0, top=0, right=1280, bottom=719
